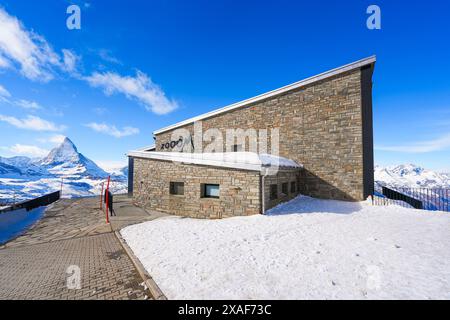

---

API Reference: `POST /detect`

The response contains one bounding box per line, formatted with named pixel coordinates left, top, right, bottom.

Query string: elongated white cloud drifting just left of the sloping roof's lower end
left=85, top=71, right=178, bottom=114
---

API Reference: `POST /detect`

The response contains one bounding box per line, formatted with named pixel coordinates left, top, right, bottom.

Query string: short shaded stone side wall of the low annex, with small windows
left=264, top=169, right=300, bottom=211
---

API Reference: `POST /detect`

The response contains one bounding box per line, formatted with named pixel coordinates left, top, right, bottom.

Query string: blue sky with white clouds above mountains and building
left=0, top=0, right=450, bottom=171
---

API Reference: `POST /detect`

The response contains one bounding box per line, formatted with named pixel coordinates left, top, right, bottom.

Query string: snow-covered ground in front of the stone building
left=121, top=196, right=450, bottom=299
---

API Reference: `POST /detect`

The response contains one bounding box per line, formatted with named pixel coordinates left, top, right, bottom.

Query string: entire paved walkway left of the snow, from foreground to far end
left=0, top=198, right=159, bottom=299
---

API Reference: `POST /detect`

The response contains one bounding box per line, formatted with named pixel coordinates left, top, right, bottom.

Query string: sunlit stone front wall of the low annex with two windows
left=133, top=158, right=261, bottom=218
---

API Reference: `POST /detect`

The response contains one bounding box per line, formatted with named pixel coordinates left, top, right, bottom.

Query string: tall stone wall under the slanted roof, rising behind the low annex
left=156, top=69, right=373, bottom=200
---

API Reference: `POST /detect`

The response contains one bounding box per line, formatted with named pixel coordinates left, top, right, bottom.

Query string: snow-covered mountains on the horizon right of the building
left=375, top=164, right=450, bottom=189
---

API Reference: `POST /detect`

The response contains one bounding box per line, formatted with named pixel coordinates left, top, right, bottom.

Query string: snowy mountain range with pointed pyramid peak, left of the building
left=0, top=138, right=127, bottom=202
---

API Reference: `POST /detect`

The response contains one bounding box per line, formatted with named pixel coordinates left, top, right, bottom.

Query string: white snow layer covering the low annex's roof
left=128, top=151, right=303, bottom=171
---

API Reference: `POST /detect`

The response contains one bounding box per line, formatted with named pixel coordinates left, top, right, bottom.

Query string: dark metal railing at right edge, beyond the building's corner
left=372, top=186, right=450, bottom=212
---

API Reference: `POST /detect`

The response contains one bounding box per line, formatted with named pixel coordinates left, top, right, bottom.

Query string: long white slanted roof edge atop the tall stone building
left=153, top=55, right=377, bottom=135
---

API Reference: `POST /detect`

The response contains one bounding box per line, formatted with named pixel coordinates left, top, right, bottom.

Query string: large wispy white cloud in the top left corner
left=0, top=8, right=75, bottom=82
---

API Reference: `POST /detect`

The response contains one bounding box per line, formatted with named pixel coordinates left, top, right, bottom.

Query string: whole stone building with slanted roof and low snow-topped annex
left=128, top=57, right=376, bottom=218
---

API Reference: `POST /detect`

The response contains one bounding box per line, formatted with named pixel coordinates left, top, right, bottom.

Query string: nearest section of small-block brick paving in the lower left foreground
left=0, top=233, right=149, bottom=299
